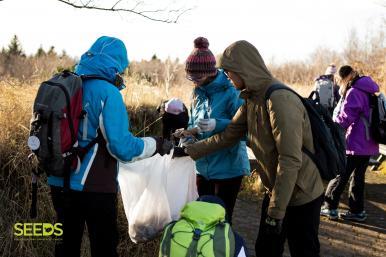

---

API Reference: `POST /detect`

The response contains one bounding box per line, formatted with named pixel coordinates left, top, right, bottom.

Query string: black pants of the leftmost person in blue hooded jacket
left=51, top=187, right=118, bottom=257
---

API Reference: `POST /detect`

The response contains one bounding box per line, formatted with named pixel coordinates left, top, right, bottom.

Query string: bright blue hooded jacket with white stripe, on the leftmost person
left=48, top=36, right=155, bottom=193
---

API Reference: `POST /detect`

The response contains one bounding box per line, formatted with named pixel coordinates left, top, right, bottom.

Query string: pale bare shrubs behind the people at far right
left=270, top=31, right=386, bottom=85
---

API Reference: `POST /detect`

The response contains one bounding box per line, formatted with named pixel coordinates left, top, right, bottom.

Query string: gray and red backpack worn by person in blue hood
left=28, top=71, right=114, bottom=183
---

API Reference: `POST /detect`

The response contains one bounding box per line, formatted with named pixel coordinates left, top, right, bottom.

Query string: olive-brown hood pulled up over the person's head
left=218, top=40, right=279, bottom=95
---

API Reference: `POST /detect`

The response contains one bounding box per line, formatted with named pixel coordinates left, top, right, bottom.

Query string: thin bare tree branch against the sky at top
left=57, top=0, right=193, bottom=23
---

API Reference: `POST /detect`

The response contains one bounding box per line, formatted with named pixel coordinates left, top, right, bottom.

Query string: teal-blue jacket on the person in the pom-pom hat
left=189, top=70, right=250, bottom=179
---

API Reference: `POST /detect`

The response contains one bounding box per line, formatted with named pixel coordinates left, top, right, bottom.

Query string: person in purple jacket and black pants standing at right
left=320, top=65, right=379, bottom=221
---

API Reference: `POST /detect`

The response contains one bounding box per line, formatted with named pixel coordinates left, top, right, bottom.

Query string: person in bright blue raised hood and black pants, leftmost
left=48, top=36, right=169, bottom=257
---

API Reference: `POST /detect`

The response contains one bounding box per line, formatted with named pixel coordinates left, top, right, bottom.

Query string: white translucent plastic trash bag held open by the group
left=118, top=153, right=198, bottom=243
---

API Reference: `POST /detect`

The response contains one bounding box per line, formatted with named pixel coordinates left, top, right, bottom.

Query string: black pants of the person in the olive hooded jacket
left=255, top=195, right=323, bottom=257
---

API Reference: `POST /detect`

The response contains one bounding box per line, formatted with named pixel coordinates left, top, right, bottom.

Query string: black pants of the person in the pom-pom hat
left=196, top=175, right=243, bottom=223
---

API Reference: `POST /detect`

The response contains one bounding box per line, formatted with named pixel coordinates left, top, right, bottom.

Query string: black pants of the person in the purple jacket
left=324, top=155, right=370, bottom=213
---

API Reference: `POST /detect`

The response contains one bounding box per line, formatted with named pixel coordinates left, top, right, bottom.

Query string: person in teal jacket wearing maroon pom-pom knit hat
left=185, top=37, right=250, bottom=222
